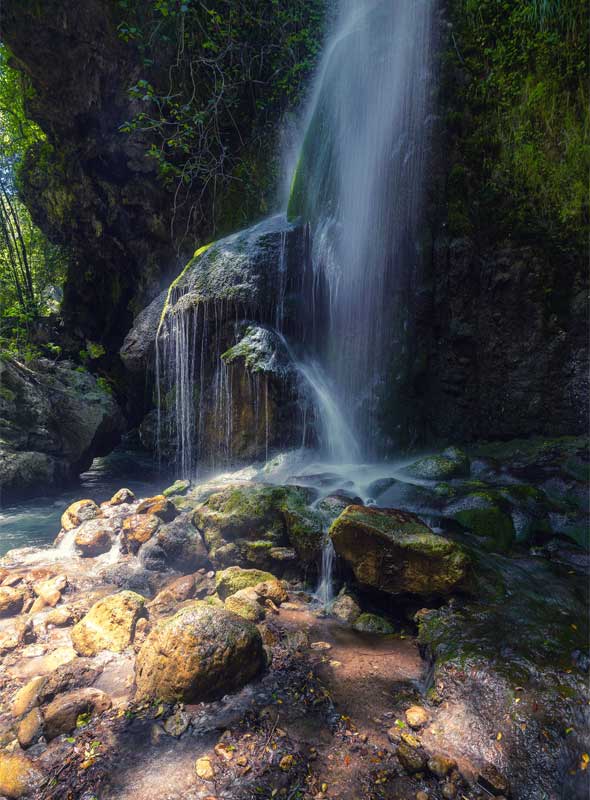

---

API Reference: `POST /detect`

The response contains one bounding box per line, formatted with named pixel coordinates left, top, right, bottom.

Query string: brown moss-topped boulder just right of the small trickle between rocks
left=330, top=506, right=469, bottom=595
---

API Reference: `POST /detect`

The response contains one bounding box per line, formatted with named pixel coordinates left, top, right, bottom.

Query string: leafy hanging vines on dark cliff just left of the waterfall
left=118, top=0, right=324, bottom=236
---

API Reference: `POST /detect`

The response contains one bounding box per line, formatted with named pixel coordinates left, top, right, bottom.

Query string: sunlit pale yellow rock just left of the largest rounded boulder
left=71, top=591, right=145, bottom=656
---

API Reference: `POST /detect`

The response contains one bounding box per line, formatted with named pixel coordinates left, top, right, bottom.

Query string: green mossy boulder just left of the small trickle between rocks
left=193, top=483, right=324, bottom=568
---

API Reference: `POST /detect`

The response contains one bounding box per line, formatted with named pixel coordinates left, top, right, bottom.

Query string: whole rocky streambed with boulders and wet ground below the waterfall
left=0, top=440, right=590, bottom=800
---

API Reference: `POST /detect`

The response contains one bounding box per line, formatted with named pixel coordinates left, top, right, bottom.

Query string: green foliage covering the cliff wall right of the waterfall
left=445, top=0, right=590, bottom=244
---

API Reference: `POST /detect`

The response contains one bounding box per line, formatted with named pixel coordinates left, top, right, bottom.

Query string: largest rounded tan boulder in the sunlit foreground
left=135, top=602, right=265, bottom=703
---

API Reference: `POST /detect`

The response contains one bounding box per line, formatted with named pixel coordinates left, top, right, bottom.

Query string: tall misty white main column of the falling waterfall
left=289, top=0, right=436, bottom=452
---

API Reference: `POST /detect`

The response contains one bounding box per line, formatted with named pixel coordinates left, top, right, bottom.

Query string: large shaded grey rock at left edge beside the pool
left=0, top=358, right=124, bottom=497
